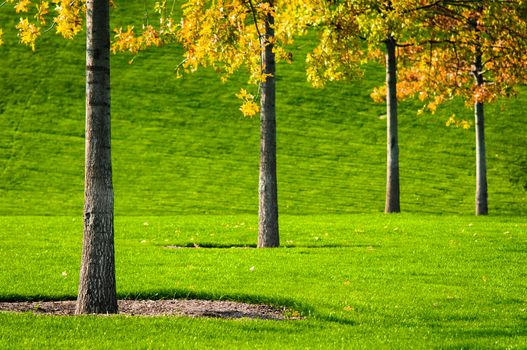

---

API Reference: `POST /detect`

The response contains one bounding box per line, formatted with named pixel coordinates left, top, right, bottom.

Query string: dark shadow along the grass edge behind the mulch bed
left=0, top=289, right=355, bottom=325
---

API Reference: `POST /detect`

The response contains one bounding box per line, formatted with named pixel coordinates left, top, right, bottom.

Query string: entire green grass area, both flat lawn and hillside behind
left=0, top=0, right=527, bottom=349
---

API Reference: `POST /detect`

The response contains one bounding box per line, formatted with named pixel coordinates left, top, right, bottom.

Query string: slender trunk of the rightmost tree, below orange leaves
left=473, top=50, right=489, bottom=215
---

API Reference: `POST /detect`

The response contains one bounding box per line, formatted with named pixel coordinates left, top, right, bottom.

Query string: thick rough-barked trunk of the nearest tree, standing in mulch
left=75, top=0, right=117, bottom=314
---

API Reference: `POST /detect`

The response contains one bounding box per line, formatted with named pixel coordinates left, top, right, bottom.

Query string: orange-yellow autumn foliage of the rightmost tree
left=401, top=0, right=527, bottom=111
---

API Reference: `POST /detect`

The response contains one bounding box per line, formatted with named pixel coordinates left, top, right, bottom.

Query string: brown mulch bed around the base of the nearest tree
left=0, top=300, right=302, bottom=320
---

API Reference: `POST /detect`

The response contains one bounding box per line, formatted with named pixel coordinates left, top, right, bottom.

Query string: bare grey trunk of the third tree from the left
left=384, top=36, right=401, bottom=213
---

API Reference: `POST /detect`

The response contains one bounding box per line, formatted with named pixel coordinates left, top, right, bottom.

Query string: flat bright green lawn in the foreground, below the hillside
left=0, top=214, right=527, bottom=349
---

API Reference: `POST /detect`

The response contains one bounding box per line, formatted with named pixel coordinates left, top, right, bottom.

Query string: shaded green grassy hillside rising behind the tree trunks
left=0, top=1, right=527, bottom=215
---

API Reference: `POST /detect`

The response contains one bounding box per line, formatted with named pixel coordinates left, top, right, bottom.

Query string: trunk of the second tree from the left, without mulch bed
left=258, top=8, right=280, bottom=248
